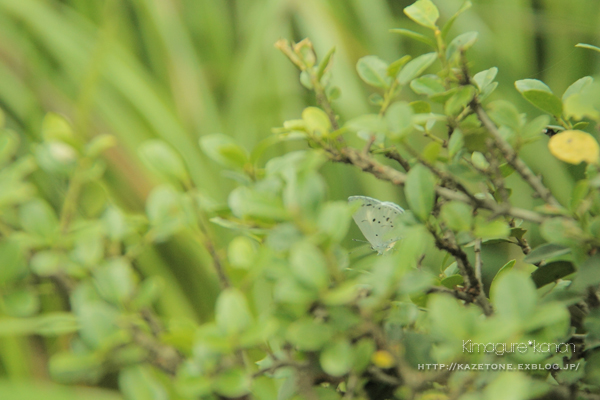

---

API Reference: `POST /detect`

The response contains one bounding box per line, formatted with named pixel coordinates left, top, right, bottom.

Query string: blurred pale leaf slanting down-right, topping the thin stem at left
left=138, top=139, right=190, bottom=182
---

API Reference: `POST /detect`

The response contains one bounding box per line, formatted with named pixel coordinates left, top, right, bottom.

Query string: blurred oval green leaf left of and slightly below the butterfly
left=290, top=241, right=329, bottom=290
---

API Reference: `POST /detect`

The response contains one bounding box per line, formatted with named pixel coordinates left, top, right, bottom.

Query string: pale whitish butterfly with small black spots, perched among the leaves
left=348, top=196, right=404, bottom=255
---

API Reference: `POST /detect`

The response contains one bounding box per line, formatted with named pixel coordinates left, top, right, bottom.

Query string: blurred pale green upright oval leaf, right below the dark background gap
left=215, top=287, right=252, bottom=335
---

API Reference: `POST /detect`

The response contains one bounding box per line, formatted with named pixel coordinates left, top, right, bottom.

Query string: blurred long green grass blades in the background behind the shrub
left=0, top=0, right=600, bottom=398
